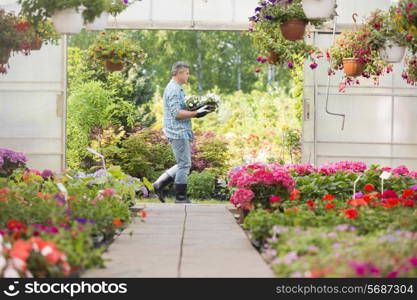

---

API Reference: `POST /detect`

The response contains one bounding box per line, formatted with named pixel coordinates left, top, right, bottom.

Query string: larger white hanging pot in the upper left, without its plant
left=52, top=8, right=84, bottom=34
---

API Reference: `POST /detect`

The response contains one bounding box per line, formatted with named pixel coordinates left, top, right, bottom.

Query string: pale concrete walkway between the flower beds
left=83, top=204, right=274, bottom=278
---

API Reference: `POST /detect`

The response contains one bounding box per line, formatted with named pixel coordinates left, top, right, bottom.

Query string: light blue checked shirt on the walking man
left=163, top=79, right=193, bottom=141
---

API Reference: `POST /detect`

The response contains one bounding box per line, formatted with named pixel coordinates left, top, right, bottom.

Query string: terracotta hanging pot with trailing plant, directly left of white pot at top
left=251, top=0, right=324, bottom=41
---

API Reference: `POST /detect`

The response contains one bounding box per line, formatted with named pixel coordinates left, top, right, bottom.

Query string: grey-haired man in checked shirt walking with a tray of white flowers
left=152, top=62, right=212, bottom=203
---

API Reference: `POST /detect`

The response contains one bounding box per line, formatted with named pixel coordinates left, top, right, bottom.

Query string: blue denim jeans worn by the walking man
left=167, top=139, right=191, bottom=184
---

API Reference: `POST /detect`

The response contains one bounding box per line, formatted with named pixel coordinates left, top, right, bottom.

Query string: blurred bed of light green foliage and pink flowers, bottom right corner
left=263, top=225, right=417, bottom=277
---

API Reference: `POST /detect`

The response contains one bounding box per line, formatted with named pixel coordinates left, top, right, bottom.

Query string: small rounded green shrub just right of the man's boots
left=187, top=171, right=216, bottom=199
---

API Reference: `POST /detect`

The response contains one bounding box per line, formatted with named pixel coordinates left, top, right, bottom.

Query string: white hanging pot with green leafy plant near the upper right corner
left=366, top=7, right=407, bottom=63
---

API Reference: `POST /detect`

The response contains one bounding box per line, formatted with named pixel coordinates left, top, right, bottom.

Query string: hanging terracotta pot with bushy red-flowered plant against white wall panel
left=327, top=26, right=392, bottom=90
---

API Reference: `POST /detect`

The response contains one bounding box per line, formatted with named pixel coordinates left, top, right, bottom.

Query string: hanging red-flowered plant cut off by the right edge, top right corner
left=394, top=0, right=417, bottom=54
